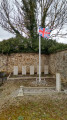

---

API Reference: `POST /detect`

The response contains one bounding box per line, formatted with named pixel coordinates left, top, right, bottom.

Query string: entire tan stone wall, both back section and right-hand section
left=0, top=50, right=67, bottom=80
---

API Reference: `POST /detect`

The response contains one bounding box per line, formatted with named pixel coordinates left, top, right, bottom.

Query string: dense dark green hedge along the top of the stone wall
left=0, top=36, right=67, bottom=54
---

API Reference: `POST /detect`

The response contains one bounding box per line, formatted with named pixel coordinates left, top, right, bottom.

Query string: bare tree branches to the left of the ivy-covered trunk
left=0, top=0, right=23, bottom=35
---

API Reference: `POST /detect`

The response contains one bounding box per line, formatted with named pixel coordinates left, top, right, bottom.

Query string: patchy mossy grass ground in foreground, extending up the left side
left=0, top=80, right=67, bottom=120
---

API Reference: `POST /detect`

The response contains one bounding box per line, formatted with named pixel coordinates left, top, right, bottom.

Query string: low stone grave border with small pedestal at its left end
left=17, top=86, right=57, bottom=96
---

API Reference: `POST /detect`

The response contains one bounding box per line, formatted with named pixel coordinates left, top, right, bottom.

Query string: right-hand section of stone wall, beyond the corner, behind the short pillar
left=49, top=50, right=67, bottom=81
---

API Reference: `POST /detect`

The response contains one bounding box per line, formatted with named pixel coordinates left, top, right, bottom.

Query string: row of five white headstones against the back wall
left=13, top=65, right=48, bottom=75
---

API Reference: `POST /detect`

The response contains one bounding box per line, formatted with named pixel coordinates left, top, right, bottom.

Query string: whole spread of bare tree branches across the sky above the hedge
left=0, top=0, right=67, bottom=36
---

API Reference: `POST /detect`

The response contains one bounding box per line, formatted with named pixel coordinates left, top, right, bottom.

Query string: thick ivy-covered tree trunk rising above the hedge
left=22, top=0, right=37, bottom=38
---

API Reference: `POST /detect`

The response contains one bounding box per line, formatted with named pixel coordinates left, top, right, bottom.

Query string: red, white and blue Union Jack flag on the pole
left=39, top=27, right=51, bottom=38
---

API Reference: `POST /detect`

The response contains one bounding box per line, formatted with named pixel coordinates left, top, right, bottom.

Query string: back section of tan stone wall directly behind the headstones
left=0, top=53, right=48, bottom=73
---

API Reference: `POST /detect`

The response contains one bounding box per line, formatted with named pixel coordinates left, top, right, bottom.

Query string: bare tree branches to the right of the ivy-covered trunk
left=38, top=0, right=67, bottom=36
